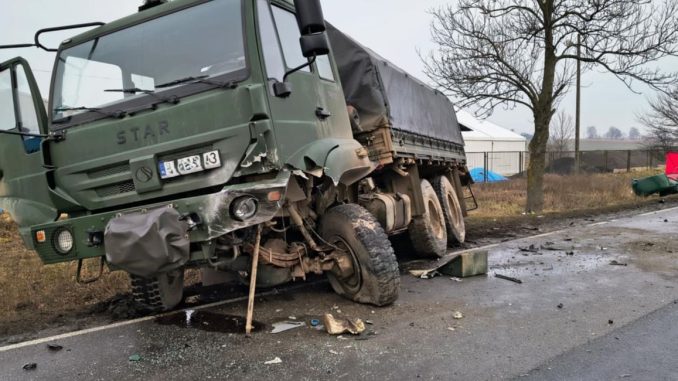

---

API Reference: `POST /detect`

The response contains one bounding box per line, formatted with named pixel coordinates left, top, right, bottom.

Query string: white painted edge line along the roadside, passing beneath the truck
left=0, top=203, right=678, bottom=353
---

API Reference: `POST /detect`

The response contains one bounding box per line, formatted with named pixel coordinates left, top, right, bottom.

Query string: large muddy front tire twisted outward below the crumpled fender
left=319, top=205, right=400, bottom=306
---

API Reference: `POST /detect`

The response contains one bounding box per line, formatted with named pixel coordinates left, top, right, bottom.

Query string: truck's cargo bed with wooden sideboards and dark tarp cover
left=327, top=24, right=465, bottom=164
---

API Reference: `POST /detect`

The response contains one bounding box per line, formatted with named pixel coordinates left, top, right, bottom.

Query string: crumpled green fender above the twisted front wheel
left=287, top=138, right=375, bottom=185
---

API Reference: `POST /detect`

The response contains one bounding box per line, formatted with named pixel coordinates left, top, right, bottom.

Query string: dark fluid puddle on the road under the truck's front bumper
left=154, top=310, right=266, bottom=333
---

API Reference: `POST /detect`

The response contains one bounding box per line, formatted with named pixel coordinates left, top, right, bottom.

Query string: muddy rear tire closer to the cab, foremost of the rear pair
left=409, top=180, right=447, bottom=258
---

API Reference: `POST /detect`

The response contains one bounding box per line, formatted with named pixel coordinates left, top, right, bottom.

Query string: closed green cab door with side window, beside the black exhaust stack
left=257, top=0, right=351, bottom=165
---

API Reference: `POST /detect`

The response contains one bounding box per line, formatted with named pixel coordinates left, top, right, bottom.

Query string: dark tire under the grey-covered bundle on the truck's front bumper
left=130, top=270, right=184, bottom=313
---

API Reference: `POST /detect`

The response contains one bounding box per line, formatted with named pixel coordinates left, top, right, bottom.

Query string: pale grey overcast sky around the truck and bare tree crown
left=0, top=0, right=676, bottom=133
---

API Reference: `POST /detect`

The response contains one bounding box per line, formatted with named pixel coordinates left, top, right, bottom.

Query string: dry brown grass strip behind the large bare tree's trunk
left=470, top=171, right=661, bottom=218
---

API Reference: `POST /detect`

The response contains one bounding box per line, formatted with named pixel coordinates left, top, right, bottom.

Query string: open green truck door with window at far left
left=0, top=58, right=58, bottom=240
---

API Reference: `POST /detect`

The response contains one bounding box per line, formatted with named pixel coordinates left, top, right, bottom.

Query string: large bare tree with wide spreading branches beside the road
left=426, top=0, right=678, bottom=212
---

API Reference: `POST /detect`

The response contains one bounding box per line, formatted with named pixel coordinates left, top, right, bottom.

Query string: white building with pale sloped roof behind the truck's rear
left=457, top=110, right=527, bottom=176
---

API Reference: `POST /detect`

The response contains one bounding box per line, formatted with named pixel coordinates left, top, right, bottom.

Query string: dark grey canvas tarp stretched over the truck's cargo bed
left=327, top=24, right=464, bottom=145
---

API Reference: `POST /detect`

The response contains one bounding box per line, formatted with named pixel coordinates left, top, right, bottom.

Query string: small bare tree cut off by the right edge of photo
left=638, top=89, right=678, bottom=153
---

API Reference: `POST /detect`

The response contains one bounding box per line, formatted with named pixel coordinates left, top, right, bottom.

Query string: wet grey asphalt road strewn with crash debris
left=0, top=210, right=678, bottom=381
